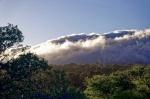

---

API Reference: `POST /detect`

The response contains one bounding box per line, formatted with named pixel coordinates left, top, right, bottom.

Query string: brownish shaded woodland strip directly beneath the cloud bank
left=53, top=63, right=129, bottom=90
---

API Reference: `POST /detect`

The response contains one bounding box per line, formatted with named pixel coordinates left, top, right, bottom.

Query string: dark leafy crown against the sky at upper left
left=0, top=24, right=23, bottom=54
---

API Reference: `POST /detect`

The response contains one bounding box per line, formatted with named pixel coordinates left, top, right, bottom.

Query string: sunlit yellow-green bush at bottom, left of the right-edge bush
left=85, top=75, right=134, bottom=99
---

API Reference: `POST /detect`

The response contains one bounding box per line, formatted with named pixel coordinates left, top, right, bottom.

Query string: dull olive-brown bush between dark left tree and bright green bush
left=32, top=68, right=84, bottom=99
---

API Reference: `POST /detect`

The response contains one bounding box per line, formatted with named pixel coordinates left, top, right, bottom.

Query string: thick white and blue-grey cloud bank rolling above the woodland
left=29, top=29, right=150, bottom=64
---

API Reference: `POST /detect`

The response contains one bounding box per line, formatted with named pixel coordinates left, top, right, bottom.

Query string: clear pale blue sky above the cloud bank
left=0, top=0, right=150, bottom=45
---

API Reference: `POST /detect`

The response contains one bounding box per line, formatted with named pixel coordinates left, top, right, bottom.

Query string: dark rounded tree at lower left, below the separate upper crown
left=0, top=53, right=48, bottom=98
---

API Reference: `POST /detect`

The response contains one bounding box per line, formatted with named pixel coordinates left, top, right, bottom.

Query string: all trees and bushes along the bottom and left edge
left=0, top=24, right=150, bottom=99
